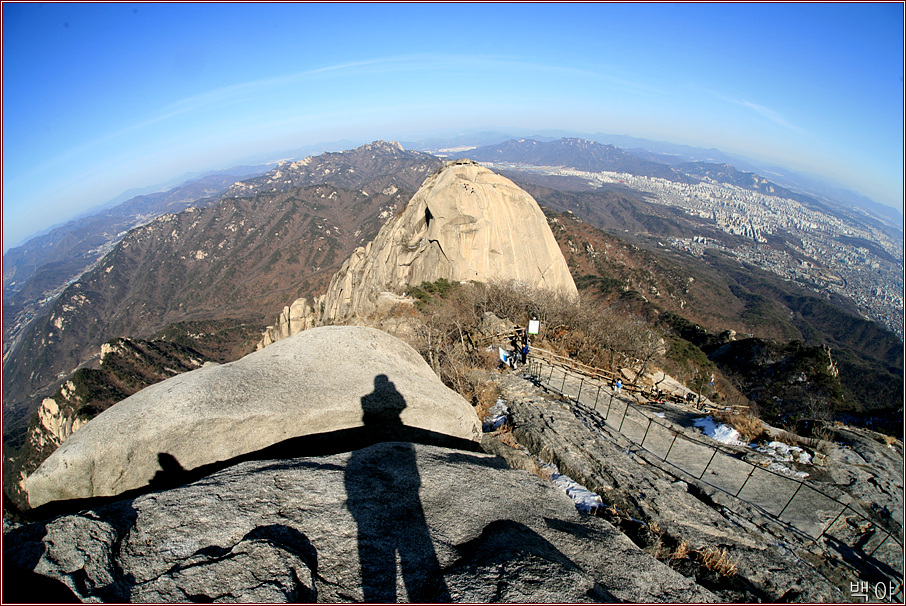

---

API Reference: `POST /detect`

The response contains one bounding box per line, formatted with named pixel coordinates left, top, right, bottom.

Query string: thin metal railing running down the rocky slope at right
left=528, top=357, right=903, bottom=580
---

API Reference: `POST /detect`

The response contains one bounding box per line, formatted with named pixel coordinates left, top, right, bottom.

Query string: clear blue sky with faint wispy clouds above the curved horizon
left=3, top=3, right=903, bottom=250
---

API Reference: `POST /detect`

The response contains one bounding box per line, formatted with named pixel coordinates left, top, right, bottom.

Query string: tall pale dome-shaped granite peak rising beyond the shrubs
left=324, top=160, right=577, bottom=321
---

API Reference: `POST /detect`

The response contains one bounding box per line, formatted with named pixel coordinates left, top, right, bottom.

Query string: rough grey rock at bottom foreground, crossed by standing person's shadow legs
left=3, top=442, right=716, bottom=603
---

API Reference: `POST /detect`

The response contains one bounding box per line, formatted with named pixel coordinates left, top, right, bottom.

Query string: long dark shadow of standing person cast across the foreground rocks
left=345, top=375, right=450, bottom=602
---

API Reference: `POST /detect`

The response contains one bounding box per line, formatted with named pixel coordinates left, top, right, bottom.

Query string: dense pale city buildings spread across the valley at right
left=486, top=163, right=903, bottom=339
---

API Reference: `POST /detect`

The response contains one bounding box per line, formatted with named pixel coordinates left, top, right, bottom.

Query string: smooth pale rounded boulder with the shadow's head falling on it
left=26, top=326, right=481, bottom=507
